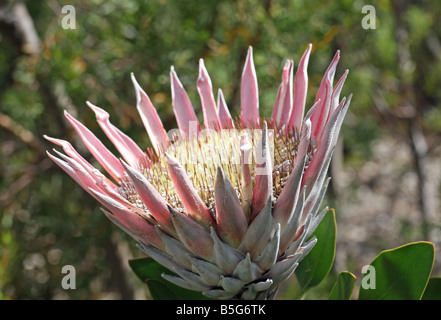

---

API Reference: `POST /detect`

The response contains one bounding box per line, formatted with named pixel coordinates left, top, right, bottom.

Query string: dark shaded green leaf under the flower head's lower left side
left=129, top=258, right=208, bottom=300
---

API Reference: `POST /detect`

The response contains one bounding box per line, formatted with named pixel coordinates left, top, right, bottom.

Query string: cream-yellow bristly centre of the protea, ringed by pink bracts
left=120, top=119, right=308, bottom=214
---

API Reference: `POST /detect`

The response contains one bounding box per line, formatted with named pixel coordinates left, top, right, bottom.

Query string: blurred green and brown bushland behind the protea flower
left=0, top=0, right=441, bottom=299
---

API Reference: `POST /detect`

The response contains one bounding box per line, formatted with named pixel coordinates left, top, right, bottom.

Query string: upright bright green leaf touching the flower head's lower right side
left=295, top=209, right=337, bottom=293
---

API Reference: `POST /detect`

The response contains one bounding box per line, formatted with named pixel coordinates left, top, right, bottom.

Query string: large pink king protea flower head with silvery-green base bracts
left=45, top=45, right=351, bottom=299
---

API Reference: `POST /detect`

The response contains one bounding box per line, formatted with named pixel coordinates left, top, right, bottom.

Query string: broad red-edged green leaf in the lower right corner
left=359, top=242, right=435, bottom=300
